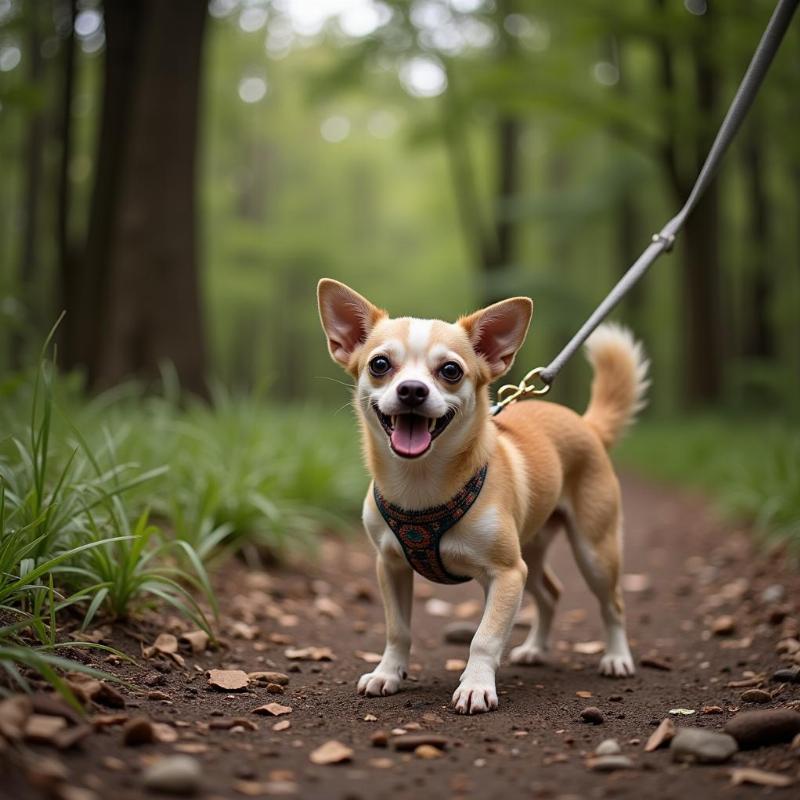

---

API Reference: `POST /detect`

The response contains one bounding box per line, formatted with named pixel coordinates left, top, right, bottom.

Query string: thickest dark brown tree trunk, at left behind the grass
left=74, top=0, right=206, bottom=394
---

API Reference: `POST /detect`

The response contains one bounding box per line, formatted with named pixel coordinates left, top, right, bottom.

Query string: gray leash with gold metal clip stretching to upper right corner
left=492, top=0, right=800, bottom=414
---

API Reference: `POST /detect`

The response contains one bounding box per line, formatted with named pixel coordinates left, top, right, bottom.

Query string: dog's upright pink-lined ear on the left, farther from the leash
left=317, top=278, right=386, bottom=369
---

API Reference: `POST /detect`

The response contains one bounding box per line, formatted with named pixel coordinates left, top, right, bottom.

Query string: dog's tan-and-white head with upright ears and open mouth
left=317, top=278, right=533, bottom=459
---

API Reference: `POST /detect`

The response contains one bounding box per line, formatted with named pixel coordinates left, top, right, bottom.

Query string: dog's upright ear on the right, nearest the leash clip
left=459, top=297, right=533, bottom=380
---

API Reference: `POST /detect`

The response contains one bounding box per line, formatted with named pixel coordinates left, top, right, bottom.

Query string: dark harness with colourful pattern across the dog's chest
left=374, top=465, right=488, bottom=583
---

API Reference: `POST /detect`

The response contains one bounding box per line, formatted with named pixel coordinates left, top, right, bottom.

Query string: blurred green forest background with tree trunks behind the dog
left=0, top=0, right=800, bottom=548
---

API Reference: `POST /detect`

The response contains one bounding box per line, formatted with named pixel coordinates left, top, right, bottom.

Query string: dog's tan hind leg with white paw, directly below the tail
left=567, top=497, right=636, bottom=678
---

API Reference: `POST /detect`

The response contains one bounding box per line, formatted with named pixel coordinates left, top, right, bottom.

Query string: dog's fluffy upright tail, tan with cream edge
left=583, top=322, right=650, bottom=448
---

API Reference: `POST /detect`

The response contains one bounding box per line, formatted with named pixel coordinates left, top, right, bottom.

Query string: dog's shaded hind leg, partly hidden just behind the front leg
left=510, top=519, right=562, bottom=664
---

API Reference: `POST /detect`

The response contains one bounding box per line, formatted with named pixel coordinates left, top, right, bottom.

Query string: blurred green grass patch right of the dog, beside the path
left=616, top=417, right=800, bottom=553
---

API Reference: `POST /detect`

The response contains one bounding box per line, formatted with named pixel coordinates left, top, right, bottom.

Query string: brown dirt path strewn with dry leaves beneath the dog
left=0, top=472, right=800, bottom=800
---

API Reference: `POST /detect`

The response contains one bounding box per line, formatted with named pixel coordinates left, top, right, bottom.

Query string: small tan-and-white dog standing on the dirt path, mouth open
left=318, top=279, right=648, bottom=714
